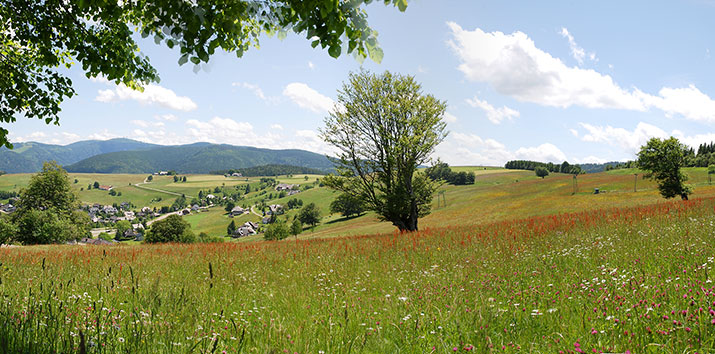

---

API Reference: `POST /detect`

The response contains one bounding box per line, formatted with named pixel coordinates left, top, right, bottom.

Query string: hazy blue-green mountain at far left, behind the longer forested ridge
left=0, top=139, right=160, bottom=173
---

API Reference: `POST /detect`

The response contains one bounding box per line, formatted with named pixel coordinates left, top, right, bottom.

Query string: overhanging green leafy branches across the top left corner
left=0, top=0, right=407, bottom=147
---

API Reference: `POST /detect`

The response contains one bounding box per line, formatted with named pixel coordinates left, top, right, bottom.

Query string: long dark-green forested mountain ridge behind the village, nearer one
left=65, top=143, right=333, bottom=173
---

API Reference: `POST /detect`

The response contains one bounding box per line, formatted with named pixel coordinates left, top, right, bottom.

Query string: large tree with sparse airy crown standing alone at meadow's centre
left=321, top=71, right=447, bottom=231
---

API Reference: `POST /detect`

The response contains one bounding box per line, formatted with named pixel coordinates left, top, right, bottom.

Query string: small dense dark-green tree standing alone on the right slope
left=636, top=137, right=692, bottom=200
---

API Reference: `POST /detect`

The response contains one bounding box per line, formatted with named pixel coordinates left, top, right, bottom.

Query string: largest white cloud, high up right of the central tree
left=448, top=22, right=646, bottom=111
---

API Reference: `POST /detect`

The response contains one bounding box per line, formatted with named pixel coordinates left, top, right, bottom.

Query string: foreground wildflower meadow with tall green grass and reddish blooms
left=0, top=195, right=715, bottom=353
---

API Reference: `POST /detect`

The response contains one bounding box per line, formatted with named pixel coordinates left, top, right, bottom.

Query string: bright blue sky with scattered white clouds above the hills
left=5, top=0, right=715, bottom=165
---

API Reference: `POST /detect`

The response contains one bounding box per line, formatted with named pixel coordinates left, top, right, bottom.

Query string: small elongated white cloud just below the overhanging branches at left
left=95, top=84, right=198, bottom=112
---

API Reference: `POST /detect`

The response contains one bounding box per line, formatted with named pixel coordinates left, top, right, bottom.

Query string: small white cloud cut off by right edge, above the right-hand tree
left=641, top=85, right=715, bottom=123
